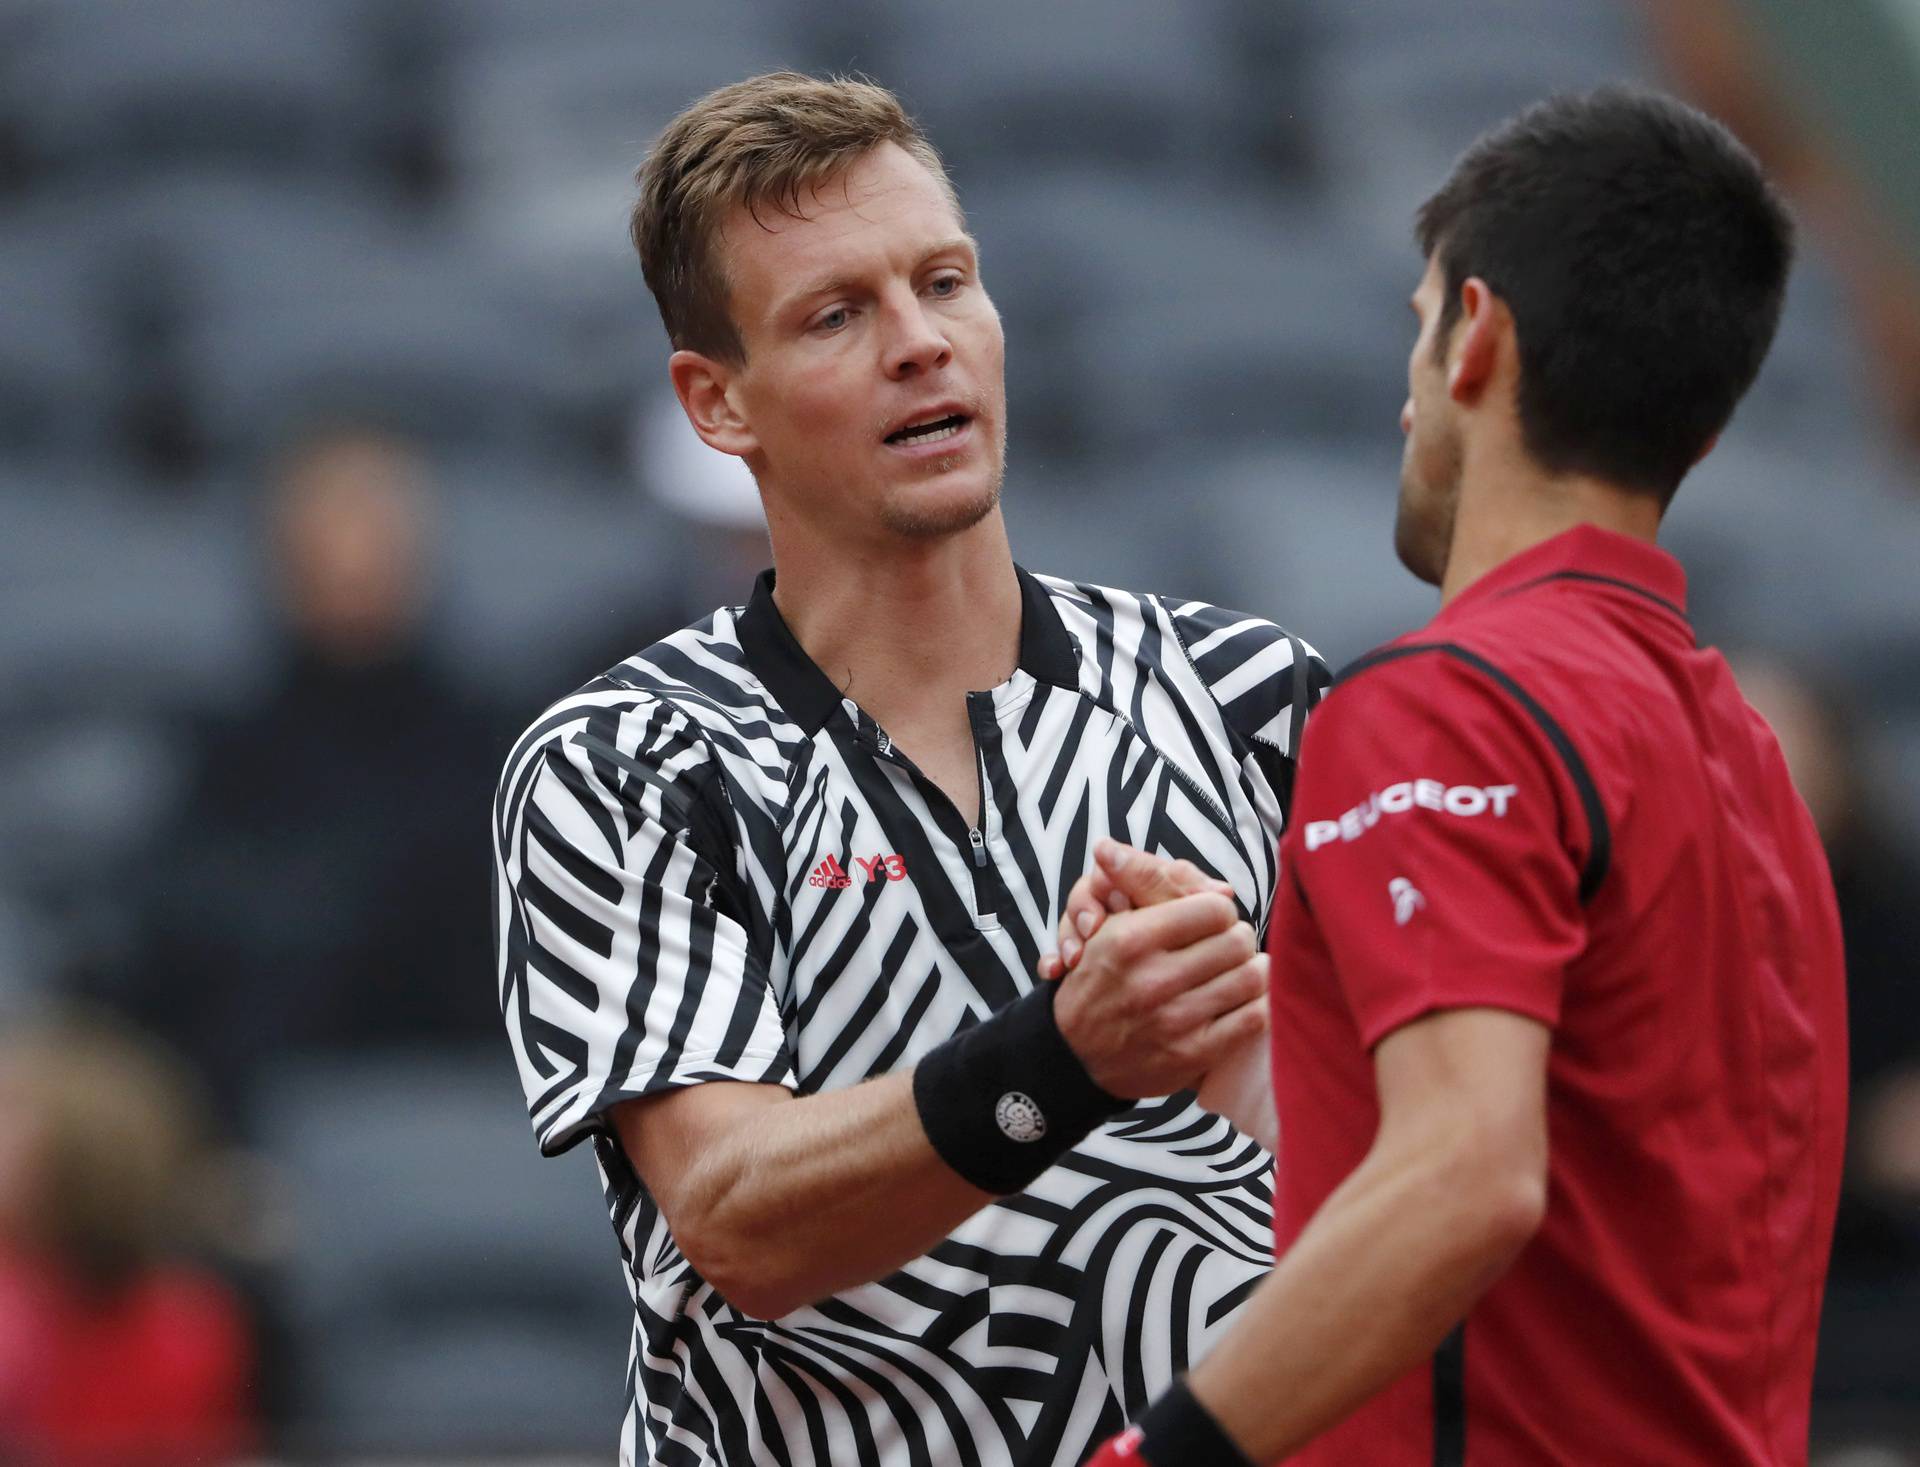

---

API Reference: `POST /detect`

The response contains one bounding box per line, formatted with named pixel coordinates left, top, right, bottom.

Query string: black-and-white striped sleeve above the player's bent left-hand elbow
left=493, top=705, right=795, bottom=1156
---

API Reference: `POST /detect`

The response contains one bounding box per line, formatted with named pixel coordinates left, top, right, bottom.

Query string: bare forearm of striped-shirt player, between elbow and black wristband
left=680, top=1073, right=991, bottom=1317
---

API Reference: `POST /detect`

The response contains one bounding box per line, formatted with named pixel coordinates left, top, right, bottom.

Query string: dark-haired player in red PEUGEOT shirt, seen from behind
left=1075, top=90, right=1847, bottom=1467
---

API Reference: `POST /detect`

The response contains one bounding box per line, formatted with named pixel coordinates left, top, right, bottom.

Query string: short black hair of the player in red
left=1415, top=86, right=1793, bottom=499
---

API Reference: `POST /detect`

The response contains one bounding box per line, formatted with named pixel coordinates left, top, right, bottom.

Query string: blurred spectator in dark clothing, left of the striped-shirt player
left=117, top=428, right=499, bottom=1116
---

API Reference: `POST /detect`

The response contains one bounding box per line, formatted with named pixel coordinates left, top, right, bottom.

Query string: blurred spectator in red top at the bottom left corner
left=0, top=1022, right=255, bottom=1467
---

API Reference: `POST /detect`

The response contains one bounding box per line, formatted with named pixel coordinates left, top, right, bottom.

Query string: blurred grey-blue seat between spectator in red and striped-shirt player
left=257, top=1052, right=630, bottom=1454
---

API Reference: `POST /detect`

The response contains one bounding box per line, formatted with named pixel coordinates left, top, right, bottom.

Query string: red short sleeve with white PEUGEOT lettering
left=1286, top=649, right=1586, bottom=1048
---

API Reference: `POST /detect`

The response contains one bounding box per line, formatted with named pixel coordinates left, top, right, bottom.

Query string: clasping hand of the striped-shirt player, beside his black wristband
left=1054, top=891, right=1267, bottom=1100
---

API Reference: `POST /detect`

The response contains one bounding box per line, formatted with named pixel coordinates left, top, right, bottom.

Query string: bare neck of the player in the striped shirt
left=774, top=509, right=1020, bottom=724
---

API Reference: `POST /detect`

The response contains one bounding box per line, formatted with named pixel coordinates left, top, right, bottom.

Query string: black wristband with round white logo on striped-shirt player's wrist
left=914, top=983, right=1133, bottom=1196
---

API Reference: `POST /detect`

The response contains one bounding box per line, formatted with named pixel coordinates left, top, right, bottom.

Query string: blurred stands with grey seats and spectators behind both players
left=0, top=0, right=1920, bottom=1467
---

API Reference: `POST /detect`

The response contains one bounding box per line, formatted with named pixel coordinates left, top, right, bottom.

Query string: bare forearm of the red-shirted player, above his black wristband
left=1188, top=1156, right=1530, bottom=1463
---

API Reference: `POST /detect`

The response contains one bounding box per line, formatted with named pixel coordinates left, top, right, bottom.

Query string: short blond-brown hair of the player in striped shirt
left=628, top=71, right=960, bottom=363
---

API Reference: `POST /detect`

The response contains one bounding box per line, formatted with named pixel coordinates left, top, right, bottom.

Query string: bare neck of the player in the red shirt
left=1440, top=447, right=1663, bottom=607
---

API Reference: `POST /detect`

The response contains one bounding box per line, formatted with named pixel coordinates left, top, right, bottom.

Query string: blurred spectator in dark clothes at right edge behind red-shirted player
left=1736, top=657, right=1920, bottom=1281
